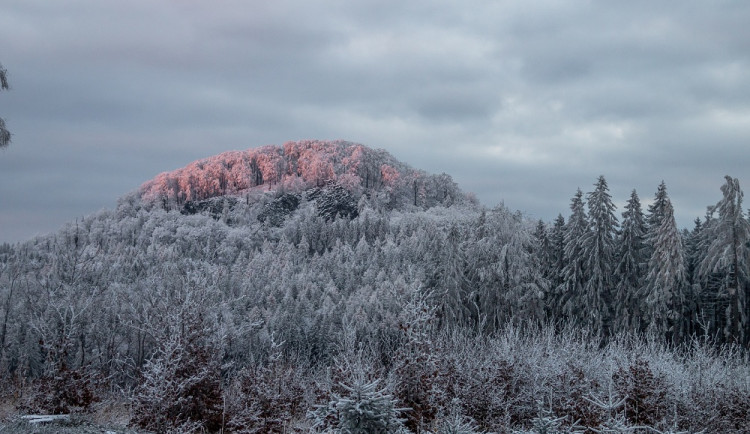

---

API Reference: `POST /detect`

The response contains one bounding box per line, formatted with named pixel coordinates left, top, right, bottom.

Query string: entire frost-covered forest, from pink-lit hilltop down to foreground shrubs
left=0, top=141, right=750, bottom=433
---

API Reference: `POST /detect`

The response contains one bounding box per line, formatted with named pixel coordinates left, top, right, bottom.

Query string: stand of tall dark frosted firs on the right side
left=535, top=176, right=750, bottom=347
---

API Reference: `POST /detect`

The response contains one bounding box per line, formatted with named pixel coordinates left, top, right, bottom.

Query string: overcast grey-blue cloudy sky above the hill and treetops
left=0, top=0, right=750, bottom=242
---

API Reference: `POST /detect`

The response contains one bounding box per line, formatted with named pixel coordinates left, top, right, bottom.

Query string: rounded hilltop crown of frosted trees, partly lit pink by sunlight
left=139, top=140, right=466, bottom=216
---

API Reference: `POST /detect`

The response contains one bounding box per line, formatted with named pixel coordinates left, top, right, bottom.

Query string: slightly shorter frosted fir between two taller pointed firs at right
left=614, top=190, right=648, bottom=332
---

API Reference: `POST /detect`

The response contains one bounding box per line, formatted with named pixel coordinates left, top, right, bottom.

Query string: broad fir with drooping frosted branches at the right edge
left=700, top=176, right=750, bottom=343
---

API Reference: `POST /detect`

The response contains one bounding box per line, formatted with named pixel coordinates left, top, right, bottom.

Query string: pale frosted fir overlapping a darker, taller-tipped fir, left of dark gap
left=646, top=196, right=687, bottom=343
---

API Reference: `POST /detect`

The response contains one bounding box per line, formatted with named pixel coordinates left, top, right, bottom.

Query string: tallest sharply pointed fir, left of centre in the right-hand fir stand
left=581, top=176, right=619, bottom=336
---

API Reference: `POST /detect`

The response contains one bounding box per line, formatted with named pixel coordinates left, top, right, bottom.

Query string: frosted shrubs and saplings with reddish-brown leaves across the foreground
left=0, top=322, right=750, bottom=434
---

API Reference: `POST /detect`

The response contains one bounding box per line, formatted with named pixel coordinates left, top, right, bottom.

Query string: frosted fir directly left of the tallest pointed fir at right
left=558, top=188, right=589, bottom=323
